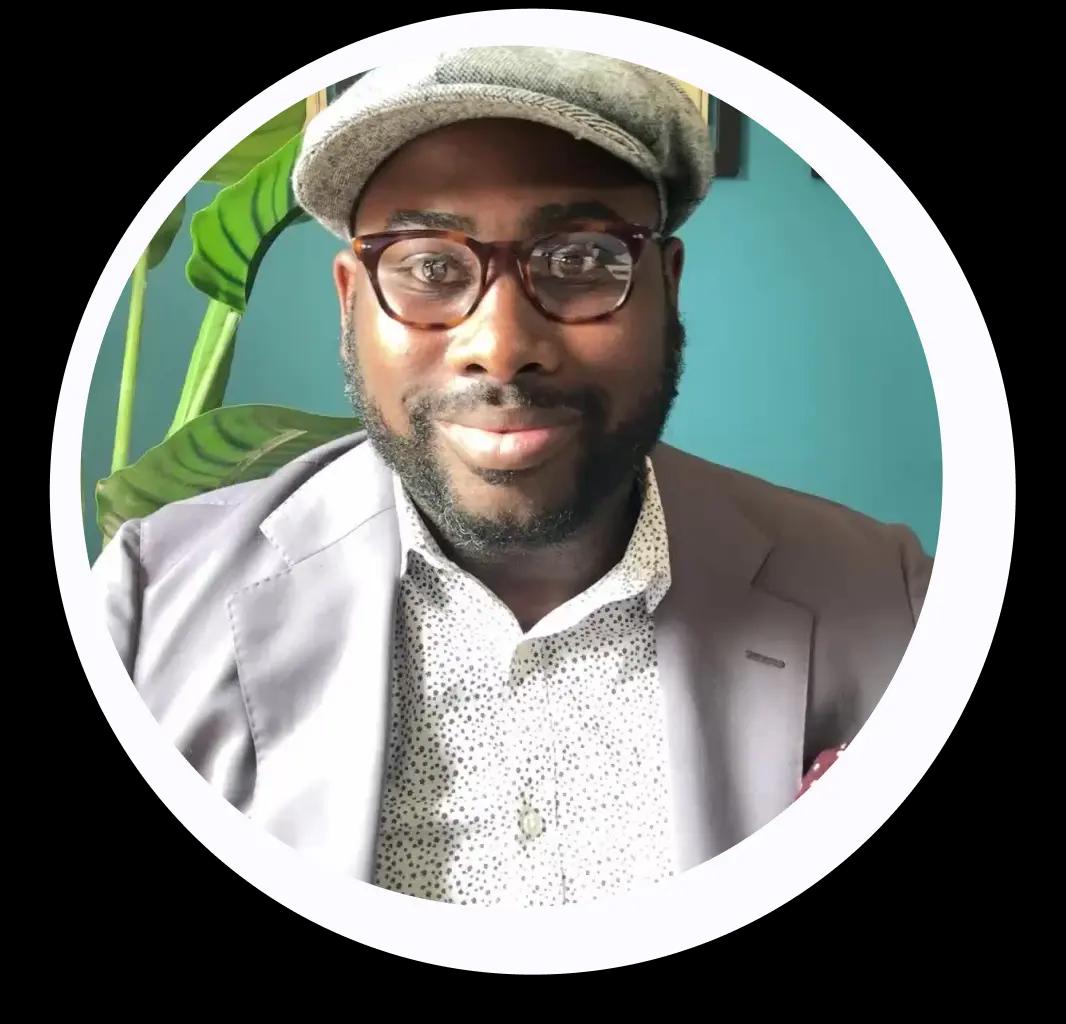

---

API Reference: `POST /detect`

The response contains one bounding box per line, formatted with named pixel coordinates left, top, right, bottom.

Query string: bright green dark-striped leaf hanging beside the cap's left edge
left=185, top=134, right=303, bottom=313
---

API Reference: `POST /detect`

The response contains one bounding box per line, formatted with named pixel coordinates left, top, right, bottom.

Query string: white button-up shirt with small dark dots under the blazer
left=375, top=460, right=675, bottom=908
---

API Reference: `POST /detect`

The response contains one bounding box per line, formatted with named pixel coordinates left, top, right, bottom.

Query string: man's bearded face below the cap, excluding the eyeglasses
left=335, top=120, right=683, bottom=551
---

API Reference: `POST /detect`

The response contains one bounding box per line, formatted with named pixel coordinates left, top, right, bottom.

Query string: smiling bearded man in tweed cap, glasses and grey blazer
left=95, top=48, right=931, bottom=907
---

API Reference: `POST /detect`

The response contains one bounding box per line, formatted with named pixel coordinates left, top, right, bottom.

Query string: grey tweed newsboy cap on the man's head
left=292, top=47, right=714, bottom=240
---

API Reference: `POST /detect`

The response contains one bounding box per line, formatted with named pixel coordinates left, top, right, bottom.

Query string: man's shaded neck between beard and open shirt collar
left=430, top=466, right=641, bottom=632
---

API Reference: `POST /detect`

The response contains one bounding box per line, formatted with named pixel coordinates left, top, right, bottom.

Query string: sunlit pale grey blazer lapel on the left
left=229, top=444, right=399, bottom=881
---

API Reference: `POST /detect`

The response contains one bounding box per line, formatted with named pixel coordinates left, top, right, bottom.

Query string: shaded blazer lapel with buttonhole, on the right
left=652, top=445, right=813, bottom=871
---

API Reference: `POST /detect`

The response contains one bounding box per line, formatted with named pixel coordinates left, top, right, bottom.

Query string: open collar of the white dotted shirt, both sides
left=392, top=457, right=671, bottom=615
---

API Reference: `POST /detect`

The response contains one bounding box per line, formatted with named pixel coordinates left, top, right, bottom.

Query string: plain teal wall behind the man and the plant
left=82, top=120, right=940, bottom=558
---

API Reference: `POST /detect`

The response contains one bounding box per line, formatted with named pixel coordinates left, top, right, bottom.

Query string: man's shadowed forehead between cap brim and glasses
left=356, top=119, right=659, bottom=233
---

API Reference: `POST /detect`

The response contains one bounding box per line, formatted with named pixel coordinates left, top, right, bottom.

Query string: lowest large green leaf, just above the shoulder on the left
left=96, top=405, right=360, bottom=543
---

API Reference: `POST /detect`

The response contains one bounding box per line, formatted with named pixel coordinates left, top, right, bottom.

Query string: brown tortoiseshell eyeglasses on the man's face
left=352, top=224, right=662, bottom=330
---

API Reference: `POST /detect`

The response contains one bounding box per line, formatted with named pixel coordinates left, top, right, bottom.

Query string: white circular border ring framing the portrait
left=50, top=10, right=1015, bottom=974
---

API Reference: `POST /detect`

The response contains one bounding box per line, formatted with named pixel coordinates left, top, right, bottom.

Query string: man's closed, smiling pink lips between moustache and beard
left=438, top=415, right=580, bottom=470
